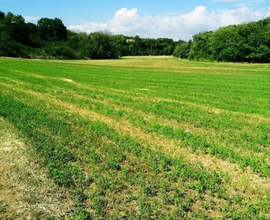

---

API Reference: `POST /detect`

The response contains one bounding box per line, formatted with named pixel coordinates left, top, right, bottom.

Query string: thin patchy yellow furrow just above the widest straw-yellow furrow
left=47, top=84, right=269, bottom=161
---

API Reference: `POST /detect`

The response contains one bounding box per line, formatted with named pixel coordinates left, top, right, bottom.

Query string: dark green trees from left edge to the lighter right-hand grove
left=0, top=11, right=178, bottom=59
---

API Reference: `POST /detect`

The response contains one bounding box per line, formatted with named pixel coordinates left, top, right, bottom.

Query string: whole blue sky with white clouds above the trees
left=0, top=0, right=270, bottom=40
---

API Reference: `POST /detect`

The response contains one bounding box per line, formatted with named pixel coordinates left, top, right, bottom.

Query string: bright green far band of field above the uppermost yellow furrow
left=6, top=58, right=270, bottom=116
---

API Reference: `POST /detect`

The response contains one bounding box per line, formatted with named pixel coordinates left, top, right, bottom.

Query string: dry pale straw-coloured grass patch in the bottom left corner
left=0, top=118, right=75, bottom=219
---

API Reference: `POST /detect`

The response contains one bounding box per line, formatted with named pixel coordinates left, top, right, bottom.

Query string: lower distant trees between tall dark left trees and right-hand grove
left=67, top=31, right=178, bottom=59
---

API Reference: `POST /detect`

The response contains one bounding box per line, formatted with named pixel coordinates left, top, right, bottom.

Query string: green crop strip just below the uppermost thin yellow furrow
left=1, top=71, right=269, bottom=156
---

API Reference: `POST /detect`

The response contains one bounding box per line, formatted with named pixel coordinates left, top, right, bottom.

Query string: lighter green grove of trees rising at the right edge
left=174, top=18, right=270, bottom=63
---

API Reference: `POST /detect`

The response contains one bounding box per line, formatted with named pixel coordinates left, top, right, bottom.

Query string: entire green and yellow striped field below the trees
left=0, top=57, right=270, bottom=219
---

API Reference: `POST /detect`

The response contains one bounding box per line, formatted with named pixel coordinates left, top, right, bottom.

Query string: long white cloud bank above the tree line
left=69, top=6, right=270, bottom=40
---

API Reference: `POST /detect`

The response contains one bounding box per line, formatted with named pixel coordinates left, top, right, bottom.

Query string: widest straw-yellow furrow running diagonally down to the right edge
left=7, top=85, right=270, bottom=198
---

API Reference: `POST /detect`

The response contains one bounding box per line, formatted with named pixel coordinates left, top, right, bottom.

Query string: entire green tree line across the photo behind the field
left=0, top=11, right=270, bottom=63
